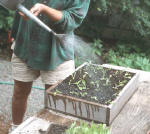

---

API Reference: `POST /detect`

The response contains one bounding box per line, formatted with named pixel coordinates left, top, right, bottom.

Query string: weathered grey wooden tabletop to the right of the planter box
left=111, top=82, right=150, bottom=134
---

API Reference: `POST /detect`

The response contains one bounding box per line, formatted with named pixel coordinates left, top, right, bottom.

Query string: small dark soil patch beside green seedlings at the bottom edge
left=46, top=124, right=68, bottom=134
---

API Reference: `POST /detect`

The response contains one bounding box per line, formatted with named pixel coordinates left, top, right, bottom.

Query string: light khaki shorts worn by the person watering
left=11, top=54, right=75, bottom=85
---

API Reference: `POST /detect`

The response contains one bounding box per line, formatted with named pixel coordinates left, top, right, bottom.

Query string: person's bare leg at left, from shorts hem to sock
left=12, top=80, right=33, bottom=125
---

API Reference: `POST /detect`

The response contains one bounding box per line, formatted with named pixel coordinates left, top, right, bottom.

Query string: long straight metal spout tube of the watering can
left=17, top=4, right=56, bottom=35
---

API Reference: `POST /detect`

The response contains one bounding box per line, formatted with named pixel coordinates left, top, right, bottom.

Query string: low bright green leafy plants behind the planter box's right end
left=104, top=42, right=150, bottom=71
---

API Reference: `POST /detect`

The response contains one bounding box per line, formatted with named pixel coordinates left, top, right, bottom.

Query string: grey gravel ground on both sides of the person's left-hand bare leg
left=0, top=51, right=44, bottom=134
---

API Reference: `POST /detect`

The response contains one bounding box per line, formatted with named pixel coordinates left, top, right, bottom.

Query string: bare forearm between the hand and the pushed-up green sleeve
left=43, top=5, right=62, bottom=22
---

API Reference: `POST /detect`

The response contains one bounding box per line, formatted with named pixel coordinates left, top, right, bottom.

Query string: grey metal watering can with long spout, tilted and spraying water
left=0, top=0, right=65, bottom=39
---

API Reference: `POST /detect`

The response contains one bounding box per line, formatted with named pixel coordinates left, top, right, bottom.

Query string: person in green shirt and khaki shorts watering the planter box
left=11, top=0, right=90, bottom=132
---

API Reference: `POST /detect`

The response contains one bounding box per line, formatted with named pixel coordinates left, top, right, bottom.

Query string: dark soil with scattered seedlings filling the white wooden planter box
left=52, top=64, right=134, bottom=105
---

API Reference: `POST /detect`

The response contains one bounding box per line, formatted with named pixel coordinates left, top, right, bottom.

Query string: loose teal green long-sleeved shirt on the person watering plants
left=12, top=0, right=90, bottom=70
